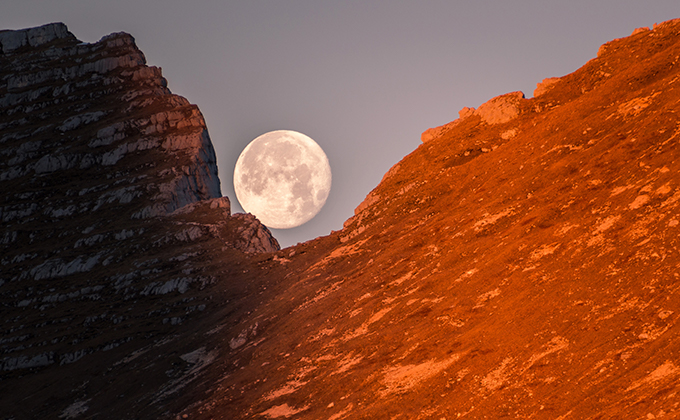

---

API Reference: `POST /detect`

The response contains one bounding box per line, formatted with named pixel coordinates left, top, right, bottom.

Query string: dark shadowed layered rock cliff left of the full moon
left=0, top=23, right=278, bottom=418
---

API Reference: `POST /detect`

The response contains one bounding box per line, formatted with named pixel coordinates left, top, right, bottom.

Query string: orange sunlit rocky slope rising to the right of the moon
left=182, top=21, right=680, bottom=420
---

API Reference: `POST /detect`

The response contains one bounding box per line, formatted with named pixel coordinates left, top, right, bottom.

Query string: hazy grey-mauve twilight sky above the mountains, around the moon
left=0, top=0, right=680, bottom=247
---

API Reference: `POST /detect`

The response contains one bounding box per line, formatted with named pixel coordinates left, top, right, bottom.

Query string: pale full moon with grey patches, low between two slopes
left=234, top=130, right=331, bottom=229
